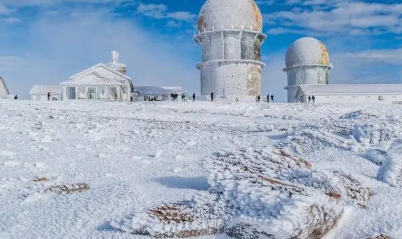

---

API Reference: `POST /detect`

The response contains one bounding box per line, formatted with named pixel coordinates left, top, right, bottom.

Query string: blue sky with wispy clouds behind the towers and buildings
left=0, top=0, right=402, bottom=101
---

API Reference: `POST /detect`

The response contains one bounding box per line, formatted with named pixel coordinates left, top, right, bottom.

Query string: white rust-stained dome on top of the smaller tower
left=286, top=37, right=331, bottom=67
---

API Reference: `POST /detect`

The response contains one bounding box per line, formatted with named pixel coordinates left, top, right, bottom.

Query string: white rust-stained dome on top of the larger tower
left=198, top=0, right=262, bottom=32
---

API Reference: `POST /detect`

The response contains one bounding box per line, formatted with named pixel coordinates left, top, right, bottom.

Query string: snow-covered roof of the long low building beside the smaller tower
left=299, top=84, right=402, bottom=95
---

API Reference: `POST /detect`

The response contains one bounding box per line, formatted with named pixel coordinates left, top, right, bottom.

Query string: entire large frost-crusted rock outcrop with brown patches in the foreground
left=111, top=147, right=372, bottom=238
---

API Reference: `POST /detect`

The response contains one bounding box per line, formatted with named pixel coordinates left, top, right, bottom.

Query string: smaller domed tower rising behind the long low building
left=283, top=37, right=332, bottom=102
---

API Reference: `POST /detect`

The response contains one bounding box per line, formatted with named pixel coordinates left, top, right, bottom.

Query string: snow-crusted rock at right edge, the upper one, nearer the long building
left=353, top=123, right=401, bottom=145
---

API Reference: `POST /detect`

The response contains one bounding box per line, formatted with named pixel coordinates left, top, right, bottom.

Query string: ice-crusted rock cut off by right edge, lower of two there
left=377, top=139, right=402, bottom=187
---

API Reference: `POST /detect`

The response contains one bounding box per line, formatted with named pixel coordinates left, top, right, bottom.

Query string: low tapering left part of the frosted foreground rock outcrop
left=111, top=194, right=227, bottom=238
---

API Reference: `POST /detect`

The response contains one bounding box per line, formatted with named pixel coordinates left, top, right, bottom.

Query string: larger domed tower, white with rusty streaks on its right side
left=194, top=0, right=266, bottom=100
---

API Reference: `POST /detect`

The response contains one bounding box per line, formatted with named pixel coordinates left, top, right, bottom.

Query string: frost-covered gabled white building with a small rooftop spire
left=60, top=51, right=133, bottom=101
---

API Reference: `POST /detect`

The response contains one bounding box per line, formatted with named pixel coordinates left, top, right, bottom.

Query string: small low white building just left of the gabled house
left=29, top=85, right=63, bottom=101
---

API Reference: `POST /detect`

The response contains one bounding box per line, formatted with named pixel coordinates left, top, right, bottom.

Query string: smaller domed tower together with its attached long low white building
left=284, top=37, right=402, bottom=104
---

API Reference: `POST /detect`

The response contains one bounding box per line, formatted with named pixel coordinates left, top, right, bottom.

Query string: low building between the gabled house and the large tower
left=134, top=86, right=184, bottom=101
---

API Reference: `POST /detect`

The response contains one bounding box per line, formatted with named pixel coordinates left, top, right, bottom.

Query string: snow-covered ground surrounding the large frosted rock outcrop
left=0, top=101, right=402, bottom=239
